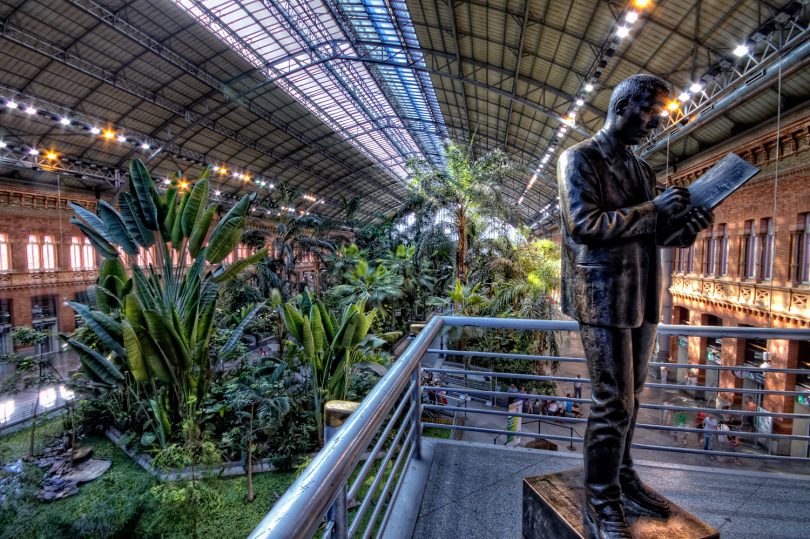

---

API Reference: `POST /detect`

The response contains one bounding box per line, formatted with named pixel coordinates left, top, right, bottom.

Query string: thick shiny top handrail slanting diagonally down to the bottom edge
left=249, top=317, right=442, bottom=539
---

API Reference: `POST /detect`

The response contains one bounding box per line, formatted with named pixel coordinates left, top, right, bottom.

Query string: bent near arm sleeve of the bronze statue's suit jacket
left=557, top=148, right=657, bottom=244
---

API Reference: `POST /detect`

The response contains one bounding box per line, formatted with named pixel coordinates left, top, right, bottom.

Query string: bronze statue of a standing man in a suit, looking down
left=557, top=75, right=714, bottom=538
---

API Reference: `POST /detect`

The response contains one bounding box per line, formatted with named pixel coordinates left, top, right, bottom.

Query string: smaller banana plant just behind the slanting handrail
left=280, top=291, right=377, bottom=441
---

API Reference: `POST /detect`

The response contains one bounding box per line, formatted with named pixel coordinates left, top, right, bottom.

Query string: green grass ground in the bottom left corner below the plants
left=0, top=419, right=295, bottom=539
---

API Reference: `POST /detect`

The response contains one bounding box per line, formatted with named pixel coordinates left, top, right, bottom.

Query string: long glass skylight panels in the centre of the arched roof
left=174, top=0, right=444, bottom=178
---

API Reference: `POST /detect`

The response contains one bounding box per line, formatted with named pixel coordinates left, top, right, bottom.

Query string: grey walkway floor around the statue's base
left=385, top=438, right=810, bottom=539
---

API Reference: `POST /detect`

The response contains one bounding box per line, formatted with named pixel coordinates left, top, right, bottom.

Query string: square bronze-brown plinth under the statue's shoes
left=523, top=469, right=720, bottom=539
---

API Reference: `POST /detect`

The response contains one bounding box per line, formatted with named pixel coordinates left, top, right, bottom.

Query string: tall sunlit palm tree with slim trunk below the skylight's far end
left=406, top=138, right=513, bottom=283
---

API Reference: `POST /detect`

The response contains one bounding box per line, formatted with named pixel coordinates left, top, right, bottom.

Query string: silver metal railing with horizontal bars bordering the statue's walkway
left=250, top=316, right=810, bottom=539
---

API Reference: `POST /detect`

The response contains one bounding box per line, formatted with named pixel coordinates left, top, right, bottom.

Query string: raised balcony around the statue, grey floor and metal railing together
left=246, top=317, right=810, bottom=539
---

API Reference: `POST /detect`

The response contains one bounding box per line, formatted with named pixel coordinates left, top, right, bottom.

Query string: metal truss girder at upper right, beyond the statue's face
left=639, top=14, right=810, bottom=157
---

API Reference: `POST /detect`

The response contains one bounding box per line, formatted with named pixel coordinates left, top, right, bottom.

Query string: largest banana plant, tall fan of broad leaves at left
left=67, top=160, right=267, bottom=445
